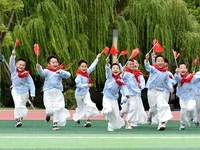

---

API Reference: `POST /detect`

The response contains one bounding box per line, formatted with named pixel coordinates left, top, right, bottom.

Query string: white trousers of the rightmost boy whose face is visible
left=179, top=99, right=196, bottom=125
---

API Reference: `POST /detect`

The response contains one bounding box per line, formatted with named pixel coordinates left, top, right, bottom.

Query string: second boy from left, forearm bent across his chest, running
left=36, top=55, right=71, bottom=130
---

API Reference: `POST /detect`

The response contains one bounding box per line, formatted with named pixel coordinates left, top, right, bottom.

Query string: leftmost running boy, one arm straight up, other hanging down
left=9, top=50, right=35, bottom=127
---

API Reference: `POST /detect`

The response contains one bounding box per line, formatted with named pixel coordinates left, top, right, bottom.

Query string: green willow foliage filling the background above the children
left=0, top=0, right=200, bottom=108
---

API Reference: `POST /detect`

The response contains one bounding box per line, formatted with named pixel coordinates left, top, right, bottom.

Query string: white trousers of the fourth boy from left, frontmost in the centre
left=101, top=96, right=125, bottom=129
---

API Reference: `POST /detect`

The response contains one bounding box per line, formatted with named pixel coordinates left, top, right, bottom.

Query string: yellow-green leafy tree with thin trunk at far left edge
left=0, top=0, right=23, bottom=103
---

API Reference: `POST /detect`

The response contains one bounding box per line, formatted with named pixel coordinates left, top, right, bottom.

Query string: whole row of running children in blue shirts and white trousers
left=10, top=50, right=200, bottom=131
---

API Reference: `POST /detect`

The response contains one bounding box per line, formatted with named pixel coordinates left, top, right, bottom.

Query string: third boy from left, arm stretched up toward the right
left=73, top=54, right=101, bottom=127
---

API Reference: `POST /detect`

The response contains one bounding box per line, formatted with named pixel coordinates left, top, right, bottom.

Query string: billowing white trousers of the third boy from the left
left=73, top=92, right=99, bottom=121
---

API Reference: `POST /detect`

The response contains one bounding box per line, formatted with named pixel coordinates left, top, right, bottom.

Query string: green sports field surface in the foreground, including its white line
left=0, top=120, right=200, bottom=150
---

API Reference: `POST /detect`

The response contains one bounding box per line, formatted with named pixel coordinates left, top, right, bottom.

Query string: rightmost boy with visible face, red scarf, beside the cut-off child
left=174, top=63, right=200, bottom=130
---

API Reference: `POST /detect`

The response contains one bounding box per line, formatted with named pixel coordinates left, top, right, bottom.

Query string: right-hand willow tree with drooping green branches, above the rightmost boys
left=122, top=0, right=200, bottom=72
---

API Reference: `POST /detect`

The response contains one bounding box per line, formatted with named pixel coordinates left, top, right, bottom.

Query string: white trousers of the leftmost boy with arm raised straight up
left=11, top=89, right=29, bottom=119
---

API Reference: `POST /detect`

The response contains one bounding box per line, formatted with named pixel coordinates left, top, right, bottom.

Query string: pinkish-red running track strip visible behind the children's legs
left=0, top=110, right=180, bottom=120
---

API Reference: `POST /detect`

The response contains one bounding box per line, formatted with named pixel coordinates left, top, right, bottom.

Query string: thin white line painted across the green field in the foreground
left=0, top=136, right=200, bottom=139
